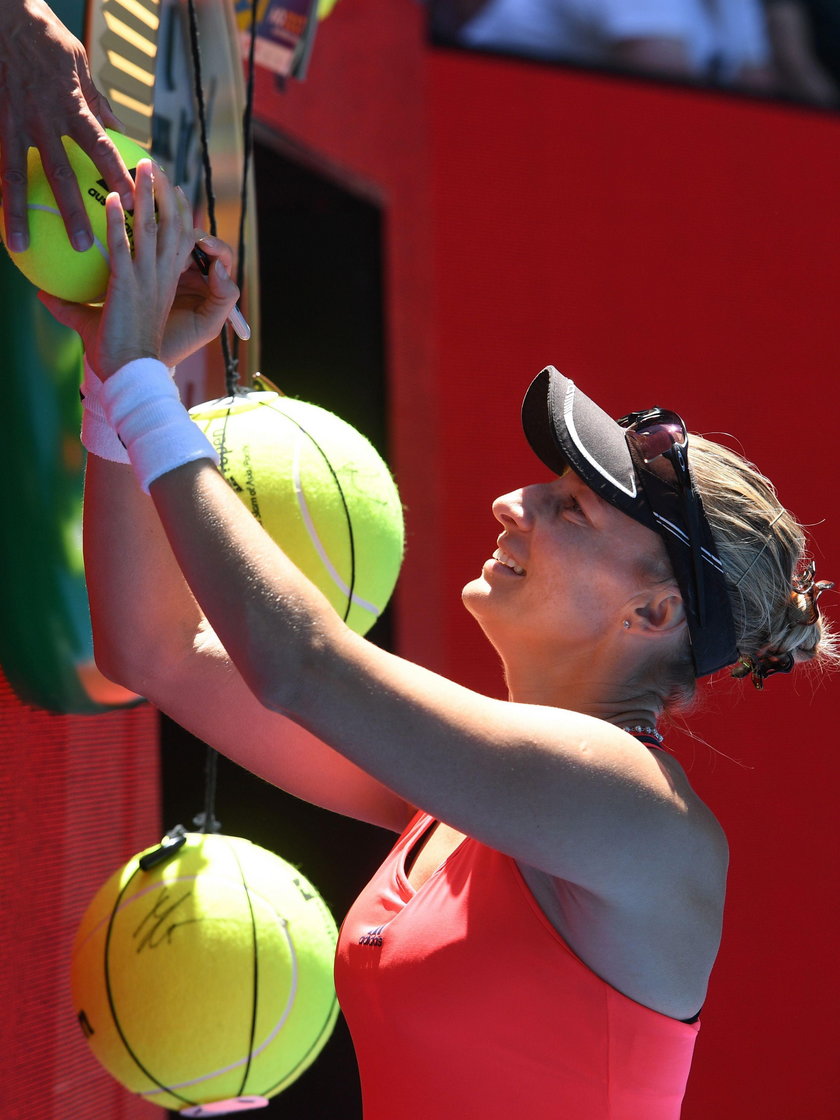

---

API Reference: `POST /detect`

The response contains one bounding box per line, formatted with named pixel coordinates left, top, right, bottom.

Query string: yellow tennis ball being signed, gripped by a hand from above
left=0, top=129, right=149, bottom=304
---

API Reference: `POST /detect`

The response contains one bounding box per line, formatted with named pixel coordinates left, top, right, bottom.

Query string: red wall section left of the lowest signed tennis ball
left=0, top=675, right=164, bottom=1120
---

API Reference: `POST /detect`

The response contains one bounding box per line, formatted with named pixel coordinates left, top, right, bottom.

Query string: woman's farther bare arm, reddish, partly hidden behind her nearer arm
left=84, top=445, right=411, bottom=831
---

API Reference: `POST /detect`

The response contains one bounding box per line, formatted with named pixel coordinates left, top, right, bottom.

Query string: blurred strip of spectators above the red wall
left=428, top=0, right=840, bottom=110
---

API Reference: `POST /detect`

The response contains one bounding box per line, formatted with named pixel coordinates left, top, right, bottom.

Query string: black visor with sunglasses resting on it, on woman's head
left=522, top=366, right=738, bottom=676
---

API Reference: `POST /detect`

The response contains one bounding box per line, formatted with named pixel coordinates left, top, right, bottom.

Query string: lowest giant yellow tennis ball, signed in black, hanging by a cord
left=72, top=833, right=337, bottom=1116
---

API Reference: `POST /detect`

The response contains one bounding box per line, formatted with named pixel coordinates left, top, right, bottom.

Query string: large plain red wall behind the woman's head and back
left=258, top=0, right=840, bottom=1120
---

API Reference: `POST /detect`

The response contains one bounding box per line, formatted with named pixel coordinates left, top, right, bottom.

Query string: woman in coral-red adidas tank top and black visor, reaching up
left=46, top=162, right=832, bottom=1120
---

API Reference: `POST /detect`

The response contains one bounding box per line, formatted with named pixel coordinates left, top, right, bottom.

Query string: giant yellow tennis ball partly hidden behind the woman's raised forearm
left=189, top=379, right=404, bottom=634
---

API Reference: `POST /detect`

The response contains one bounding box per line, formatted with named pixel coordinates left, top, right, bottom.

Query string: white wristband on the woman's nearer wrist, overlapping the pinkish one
left=101, top=357, right=218, bottom=494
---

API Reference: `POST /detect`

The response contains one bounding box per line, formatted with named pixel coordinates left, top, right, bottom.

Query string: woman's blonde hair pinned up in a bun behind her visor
left=668, top=435, right=840, bottom=707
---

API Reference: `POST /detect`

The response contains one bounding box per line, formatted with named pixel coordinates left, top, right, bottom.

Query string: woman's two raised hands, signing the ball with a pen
left=39, top=160, right=239, bottom=377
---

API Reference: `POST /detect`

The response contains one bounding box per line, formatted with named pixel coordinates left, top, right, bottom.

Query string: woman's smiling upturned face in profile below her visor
left=463, top=472, right=670, bottom=661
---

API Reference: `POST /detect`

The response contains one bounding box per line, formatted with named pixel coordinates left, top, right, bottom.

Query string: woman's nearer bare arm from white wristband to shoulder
left=143, top=448, right=719, bottom=895
